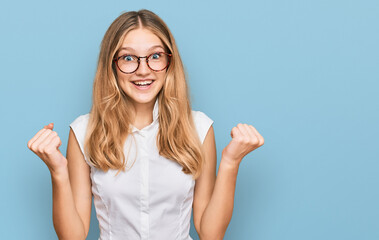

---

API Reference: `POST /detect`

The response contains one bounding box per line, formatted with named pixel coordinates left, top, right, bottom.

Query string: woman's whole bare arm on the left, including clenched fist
left=28, top=124, right=92, bottom=240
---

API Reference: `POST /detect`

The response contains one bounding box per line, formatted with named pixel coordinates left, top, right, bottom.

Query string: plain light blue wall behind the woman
left=0, top=0, right=379, bottom=240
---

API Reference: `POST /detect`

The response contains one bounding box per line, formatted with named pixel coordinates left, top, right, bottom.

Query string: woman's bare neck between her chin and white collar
left=133, top=99, right=155, bottom=129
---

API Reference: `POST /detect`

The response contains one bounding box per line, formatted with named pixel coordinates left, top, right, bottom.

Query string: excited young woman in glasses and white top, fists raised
left=28, top=10, right=264, bottom=240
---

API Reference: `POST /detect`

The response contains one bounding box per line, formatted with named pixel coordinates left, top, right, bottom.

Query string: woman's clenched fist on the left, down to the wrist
left=28, top=123, right=67, bottom=173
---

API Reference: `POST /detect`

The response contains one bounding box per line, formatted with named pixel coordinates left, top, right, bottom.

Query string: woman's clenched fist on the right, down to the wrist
left=222, top=123, right=264, bottom=164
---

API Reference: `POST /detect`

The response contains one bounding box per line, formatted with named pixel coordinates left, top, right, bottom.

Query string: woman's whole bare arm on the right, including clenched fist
left=193, top=124, right=264, bottom=240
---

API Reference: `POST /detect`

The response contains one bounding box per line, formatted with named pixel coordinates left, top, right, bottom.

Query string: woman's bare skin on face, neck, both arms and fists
left=28, top=29, right=264, bottom=240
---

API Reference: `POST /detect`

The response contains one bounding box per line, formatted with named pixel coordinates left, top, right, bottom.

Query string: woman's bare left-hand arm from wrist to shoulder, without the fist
left=51, top=130, right=92, bottom=240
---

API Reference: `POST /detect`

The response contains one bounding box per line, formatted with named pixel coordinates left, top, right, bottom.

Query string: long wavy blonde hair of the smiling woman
left=85, top=9, right=203, bottom=179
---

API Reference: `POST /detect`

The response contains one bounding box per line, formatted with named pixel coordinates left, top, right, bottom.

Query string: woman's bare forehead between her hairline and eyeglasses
left=121, top=28, right=163, bottom=52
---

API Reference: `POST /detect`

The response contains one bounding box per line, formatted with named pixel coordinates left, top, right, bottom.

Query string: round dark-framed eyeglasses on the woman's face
left=113, top=52, right=172, bottom=74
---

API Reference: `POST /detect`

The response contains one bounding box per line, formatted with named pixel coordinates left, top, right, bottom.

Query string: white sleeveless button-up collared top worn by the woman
left=70, top=98, right=213, bottom=240
